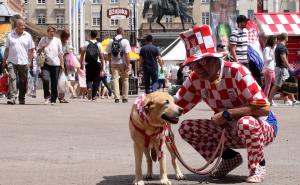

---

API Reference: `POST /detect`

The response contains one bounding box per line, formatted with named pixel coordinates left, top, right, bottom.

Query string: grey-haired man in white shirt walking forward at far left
left=2, top=19, right=34, bottom=105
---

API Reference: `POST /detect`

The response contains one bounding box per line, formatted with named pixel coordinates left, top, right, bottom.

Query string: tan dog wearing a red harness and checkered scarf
left=129, top=92, right=184, bottom=185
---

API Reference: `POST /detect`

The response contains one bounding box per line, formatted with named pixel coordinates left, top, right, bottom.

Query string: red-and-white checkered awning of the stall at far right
left=255, top=13, right=300, bottom=35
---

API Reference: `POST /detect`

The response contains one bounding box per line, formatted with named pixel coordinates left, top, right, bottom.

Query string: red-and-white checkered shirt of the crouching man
left=174, top=62, right=269, bottom=113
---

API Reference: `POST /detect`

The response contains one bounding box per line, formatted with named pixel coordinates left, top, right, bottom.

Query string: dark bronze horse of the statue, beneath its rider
left=143, top=0, right=195, bottom=32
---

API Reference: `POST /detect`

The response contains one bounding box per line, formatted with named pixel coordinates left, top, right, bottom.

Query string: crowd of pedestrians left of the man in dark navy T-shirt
left=0, top=19, right=138, bottom=105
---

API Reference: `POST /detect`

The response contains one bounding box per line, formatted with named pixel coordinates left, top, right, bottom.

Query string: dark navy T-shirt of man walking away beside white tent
left=140, top=44, right=160, bottom=71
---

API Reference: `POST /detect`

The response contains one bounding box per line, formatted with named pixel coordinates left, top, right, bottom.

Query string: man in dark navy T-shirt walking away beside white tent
left=140, top=35, right=162, bottom=94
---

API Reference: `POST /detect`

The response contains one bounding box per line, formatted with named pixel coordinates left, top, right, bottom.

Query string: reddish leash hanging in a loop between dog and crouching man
left=166, top=129, right=225, bottom=175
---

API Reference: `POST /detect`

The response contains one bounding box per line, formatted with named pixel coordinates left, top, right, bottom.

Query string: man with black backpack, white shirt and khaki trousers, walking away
left=106, top=27, right=131, bottom=103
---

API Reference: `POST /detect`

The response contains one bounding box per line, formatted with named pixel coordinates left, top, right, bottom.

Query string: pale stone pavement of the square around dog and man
left=0, top=92, right=300, bottom=185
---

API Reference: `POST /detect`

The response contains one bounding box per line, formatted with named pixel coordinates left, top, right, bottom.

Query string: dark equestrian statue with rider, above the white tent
left=143, top=0, right=195, bottom=32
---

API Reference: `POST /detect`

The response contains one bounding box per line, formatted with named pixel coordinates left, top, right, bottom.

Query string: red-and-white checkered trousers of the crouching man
left=179, top=116, right=275, bottom=169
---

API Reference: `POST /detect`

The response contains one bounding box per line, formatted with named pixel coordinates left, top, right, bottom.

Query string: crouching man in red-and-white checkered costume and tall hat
left=174, top=25, right=277, bottom=182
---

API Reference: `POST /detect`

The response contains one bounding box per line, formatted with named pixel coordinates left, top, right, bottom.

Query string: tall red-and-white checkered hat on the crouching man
left=180, top=25, right=225, bottom=65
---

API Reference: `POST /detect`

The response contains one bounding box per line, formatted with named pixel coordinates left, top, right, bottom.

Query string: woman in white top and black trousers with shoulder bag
left=37, top=26, right=64, bottom=105
